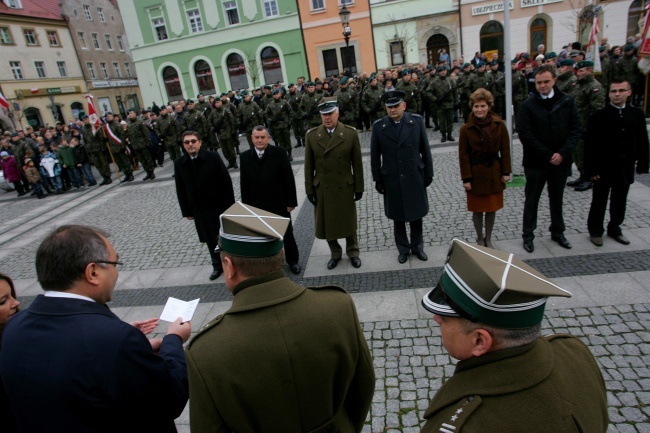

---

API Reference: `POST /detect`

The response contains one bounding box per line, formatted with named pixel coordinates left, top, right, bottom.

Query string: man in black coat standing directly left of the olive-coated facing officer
left=239, top=125, right=301, bottom=275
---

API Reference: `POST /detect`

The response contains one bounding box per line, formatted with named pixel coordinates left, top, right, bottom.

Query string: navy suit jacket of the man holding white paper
left=0, top=295, right=189, bottom=433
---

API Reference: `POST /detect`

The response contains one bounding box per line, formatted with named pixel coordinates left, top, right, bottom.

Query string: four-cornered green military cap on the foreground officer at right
left=422, top=239, right=571, bottom=329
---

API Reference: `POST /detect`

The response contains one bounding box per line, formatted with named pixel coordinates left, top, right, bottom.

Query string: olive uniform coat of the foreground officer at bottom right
left=422, top=334, right=609, bottom=433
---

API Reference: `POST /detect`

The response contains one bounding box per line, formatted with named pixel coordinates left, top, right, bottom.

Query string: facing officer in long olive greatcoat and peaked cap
left=305, top=96, right=363, bottom=269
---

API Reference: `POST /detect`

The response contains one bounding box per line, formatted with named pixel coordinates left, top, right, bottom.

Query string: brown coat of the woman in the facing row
left=458, top=113, right=512, bottom=195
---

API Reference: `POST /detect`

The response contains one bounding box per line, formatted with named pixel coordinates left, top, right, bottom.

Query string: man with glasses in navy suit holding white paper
left=0, top=226, right=191, bottom=433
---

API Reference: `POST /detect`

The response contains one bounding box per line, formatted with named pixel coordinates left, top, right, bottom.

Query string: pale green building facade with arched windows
left=119, top=0, right=307, bottom=105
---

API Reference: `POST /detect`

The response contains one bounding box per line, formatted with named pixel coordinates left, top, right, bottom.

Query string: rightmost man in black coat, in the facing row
left=585, top=79, right=649, bottom=247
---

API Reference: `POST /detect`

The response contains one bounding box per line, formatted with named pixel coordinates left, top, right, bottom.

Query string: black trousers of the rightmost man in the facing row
left=587, top=177, right=630, bottom=236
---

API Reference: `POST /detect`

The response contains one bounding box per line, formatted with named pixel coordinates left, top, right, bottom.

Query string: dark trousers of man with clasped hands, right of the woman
left=522, top=164, right=568, bottom=240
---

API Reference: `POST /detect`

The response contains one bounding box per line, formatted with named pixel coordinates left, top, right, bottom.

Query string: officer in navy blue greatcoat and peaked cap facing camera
left=370, top=90, right=433, bottom=263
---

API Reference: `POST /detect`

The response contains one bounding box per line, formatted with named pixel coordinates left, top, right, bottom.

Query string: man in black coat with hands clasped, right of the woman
left=517, top=65, right=581, bottom=253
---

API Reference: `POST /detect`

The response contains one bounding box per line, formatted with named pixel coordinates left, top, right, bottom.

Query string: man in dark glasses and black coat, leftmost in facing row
left=174, top=131, right=235, bottom=280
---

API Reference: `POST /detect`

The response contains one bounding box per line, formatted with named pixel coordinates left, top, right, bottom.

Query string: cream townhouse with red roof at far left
left=0, top=0, right=87, bottom=130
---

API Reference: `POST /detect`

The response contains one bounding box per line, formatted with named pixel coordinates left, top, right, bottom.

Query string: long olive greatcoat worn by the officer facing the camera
left=303, top=121, right=363, bottom=240
